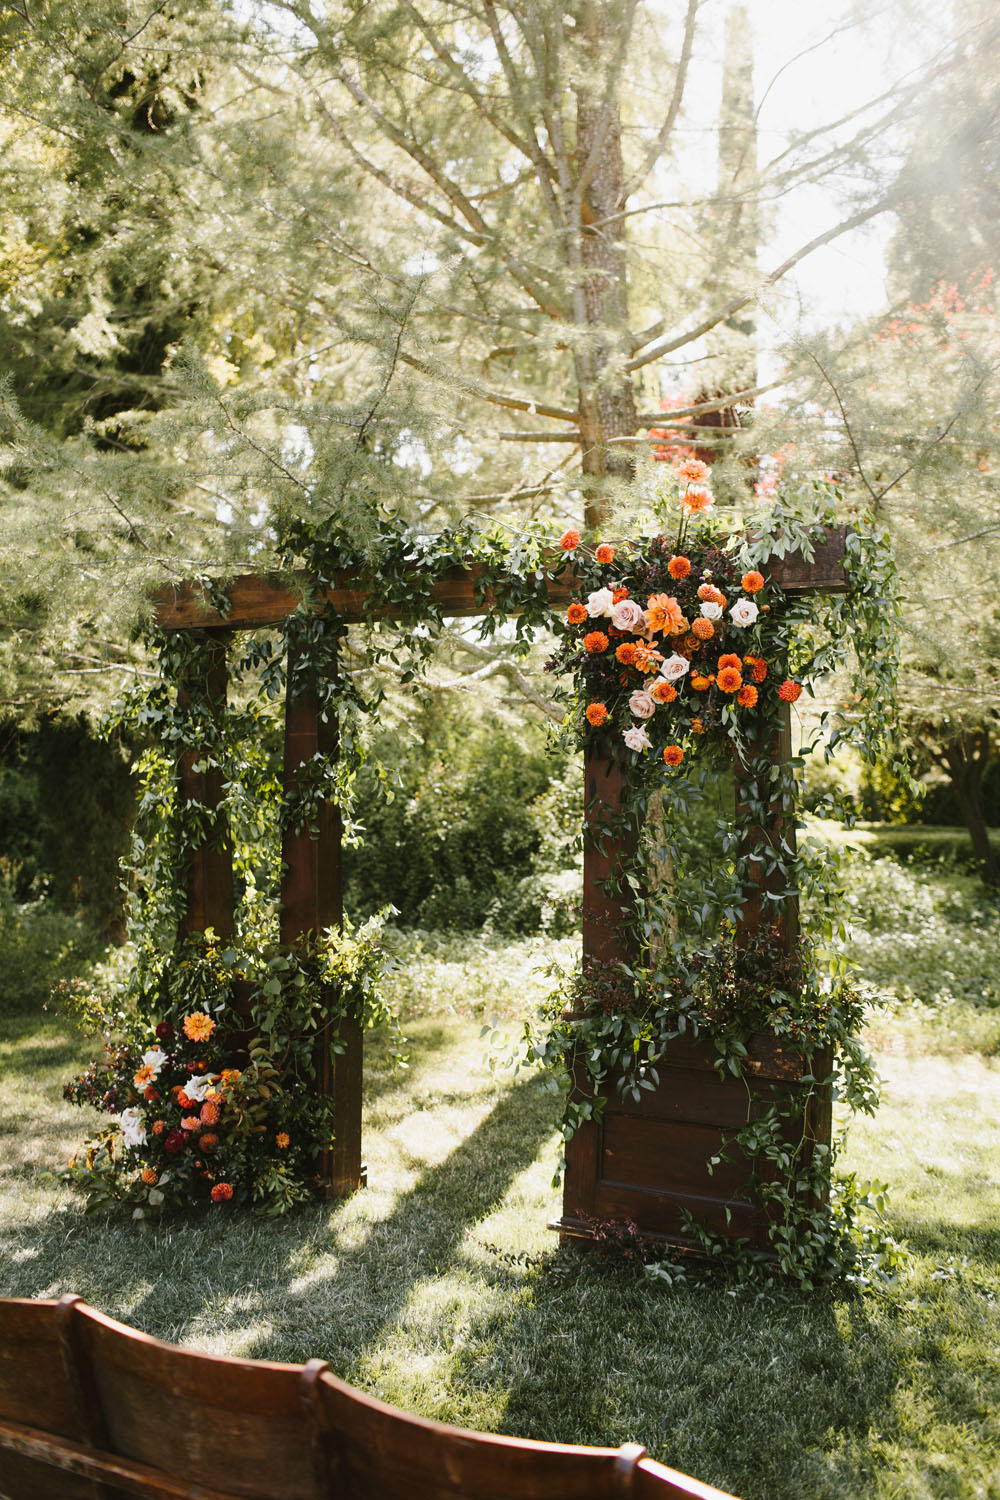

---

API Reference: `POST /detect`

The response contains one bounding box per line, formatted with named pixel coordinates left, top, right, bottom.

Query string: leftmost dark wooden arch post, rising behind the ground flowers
left=177, top=630, right=234, bottom=942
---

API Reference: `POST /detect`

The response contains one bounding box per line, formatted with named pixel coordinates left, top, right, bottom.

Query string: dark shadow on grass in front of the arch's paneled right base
left=443, top=1251, right=900, bottom=1500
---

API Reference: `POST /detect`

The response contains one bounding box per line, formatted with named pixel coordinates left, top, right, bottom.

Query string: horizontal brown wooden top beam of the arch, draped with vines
left=153, top=527, right=847, bottom=630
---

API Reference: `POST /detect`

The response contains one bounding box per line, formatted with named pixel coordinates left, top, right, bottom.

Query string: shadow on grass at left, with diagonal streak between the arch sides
left=0, top=1080, right=552, bottom=1379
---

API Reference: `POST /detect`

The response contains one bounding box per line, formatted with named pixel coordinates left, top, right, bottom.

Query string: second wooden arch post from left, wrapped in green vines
left=280, top=647, right=366, bottom=1197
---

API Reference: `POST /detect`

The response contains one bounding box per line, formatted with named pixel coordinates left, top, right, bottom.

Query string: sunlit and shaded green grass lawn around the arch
left=0, top=912, right=1000, bottom=1500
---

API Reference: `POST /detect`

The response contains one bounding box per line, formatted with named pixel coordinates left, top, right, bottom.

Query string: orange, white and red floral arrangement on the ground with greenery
left=64, top=917, right=390, bottom=1218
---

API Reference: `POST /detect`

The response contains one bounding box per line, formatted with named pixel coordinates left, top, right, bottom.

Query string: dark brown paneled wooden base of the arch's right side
left=553, top=1034, right=831, bottom=1253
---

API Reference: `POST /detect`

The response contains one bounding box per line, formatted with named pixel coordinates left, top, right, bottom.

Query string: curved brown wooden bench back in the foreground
left=0, top=1296, right=732, bottom=1500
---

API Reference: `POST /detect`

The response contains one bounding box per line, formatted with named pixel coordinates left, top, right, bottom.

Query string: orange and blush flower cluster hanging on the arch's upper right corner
left=558, top=461, right=802, bottom=767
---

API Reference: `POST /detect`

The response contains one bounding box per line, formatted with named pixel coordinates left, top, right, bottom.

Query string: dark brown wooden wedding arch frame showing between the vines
left=156, top=527, right=847, bottom=1238
